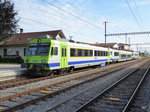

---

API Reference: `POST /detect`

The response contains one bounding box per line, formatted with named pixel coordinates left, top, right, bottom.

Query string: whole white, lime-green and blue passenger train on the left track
left=24, top=38, right=139, bottom=76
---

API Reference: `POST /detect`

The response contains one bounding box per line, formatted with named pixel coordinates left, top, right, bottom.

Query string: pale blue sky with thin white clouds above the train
left=11, top=0, right=150, bottom=51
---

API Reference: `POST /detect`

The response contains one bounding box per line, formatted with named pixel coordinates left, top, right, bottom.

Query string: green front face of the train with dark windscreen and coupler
left=24, top=39, right=51, bottom=76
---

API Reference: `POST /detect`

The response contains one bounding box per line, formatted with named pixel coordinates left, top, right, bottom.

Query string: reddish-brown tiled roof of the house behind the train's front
left=0, top=30, right=63, bottom=45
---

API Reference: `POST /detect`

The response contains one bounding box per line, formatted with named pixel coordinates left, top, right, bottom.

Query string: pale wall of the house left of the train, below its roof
left=0, top=46, right=26, bottom=59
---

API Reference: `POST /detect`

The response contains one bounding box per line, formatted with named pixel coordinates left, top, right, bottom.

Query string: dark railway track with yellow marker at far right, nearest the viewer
left=76, top=63, right=150, bottom=112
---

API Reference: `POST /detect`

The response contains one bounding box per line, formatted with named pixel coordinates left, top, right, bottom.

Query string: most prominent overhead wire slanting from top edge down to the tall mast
left=43, top=0, right=103, bottom=30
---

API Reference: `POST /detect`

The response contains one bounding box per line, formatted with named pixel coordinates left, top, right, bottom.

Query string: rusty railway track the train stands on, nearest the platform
left=0, top=60, right=143, bottom=90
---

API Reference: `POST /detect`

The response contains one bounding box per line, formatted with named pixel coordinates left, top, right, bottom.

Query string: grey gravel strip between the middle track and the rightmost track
left=14, top=59, right=146, bottom=112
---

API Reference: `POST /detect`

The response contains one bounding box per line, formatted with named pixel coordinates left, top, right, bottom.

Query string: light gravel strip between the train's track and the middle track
left=0, top=59, right=141, bottom=98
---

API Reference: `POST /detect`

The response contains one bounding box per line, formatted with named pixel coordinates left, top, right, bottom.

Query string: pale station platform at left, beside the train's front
left=0, top=64, right=26, bottom=81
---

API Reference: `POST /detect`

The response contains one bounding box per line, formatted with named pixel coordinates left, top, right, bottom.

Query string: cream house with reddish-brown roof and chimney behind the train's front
left=0, top=29, right=66, bottom=58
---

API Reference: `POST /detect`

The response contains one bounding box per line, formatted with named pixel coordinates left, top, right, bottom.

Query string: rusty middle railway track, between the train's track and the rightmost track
left=0, top=58, right=146, bottom=111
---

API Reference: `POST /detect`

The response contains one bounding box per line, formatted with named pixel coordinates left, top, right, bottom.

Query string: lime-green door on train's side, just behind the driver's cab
left=60, top=42, right=68, bottom=68
